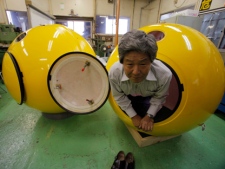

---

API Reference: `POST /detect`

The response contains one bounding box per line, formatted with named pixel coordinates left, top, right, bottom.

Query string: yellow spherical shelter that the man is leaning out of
left=106, top=23, right=225, bottom=136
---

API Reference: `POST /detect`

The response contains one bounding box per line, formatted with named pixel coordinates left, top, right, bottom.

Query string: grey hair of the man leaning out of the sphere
left=118, top=30, right=158, bottom=63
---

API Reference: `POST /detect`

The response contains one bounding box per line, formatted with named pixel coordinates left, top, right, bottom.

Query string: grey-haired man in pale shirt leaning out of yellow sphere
left=109, top=30, right=172, bottom=131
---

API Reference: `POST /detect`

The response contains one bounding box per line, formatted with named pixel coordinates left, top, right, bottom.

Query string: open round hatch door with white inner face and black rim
left=48, top=52, right=110, bottom=114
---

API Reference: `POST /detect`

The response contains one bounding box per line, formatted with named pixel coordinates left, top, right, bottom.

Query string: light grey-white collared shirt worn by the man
left=109, top=60, right=172, bottom=117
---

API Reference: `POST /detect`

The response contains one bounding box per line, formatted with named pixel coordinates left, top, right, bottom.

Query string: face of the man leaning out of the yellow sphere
left=123, top=52, right=151, bottom=83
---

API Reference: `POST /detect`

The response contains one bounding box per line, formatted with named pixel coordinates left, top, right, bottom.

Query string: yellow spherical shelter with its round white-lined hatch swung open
left=2, top=24, right=110, bottom=114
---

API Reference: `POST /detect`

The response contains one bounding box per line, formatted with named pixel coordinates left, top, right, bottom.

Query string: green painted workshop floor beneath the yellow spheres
left=0, top=84, right=225, bottom=169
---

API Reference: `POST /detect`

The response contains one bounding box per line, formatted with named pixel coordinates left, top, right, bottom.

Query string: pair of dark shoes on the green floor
left=111, top=151, right=135, bottom=169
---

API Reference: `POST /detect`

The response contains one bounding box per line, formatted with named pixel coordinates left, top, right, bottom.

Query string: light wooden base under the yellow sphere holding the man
left=125, top=124, right=180, bottom=147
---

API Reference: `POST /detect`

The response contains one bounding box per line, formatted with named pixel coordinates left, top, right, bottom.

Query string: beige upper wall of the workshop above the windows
left=0, top=0, right=225, bottom=29
